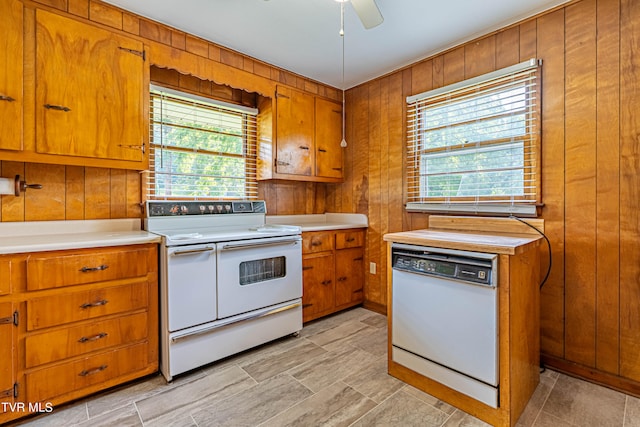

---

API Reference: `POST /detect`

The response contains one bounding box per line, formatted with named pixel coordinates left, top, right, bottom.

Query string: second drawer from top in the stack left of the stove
left=27, top=279, right=149, bottom=331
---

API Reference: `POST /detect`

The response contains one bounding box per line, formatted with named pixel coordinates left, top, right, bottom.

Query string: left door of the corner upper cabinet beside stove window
left=276, top=86, right=315, bottom=176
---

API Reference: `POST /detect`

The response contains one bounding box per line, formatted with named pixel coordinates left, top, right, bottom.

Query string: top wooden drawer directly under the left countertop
left=27, top=249, right=148, bottom=291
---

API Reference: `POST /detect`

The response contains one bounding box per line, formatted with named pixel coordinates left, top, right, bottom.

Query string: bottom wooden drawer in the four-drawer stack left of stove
left=26, top=342, right=148, bottom=402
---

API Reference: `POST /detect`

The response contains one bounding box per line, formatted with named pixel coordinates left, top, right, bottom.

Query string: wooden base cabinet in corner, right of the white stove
left=302, top=229, right=364, bottom=322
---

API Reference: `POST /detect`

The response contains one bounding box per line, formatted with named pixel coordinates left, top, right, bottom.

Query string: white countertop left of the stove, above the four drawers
left=0, top=218, right=161, bottom=254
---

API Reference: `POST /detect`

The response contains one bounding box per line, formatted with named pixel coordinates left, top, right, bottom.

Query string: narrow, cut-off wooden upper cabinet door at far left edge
left=0, top=0, right=23, bottom=150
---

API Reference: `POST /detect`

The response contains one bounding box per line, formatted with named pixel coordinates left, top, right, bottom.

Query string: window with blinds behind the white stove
left=147, top=86, right=257, bottom=199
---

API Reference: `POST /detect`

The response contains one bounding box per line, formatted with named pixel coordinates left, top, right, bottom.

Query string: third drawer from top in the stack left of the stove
left=25, top=312, right=148, bottom=368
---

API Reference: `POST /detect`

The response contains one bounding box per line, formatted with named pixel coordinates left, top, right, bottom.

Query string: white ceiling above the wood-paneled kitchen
left=104, top=0, right=568, bottom=89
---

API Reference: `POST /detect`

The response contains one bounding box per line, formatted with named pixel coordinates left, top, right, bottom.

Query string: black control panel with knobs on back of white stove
left=146, top=200, right=267, bottom=218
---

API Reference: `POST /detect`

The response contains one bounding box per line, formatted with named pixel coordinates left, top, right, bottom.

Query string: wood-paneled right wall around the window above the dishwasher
left=326, top=0, right=640, bottom=393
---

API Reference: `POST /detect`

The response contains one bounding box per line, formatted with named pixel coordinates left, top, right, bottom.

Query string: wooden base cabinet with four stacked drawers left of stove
left=0, top=244, right=158, bottom=423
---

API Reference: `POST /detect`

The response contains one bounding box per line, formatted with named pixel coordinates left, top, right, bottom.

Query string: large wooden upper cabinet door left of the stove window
left=36, top=10, right=148, bottom=162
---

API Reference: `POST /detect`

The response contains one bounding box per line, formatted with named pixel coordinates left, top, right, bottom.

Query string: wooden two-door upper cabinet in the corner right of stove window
left=258, top=86, right=343, bottom=182
